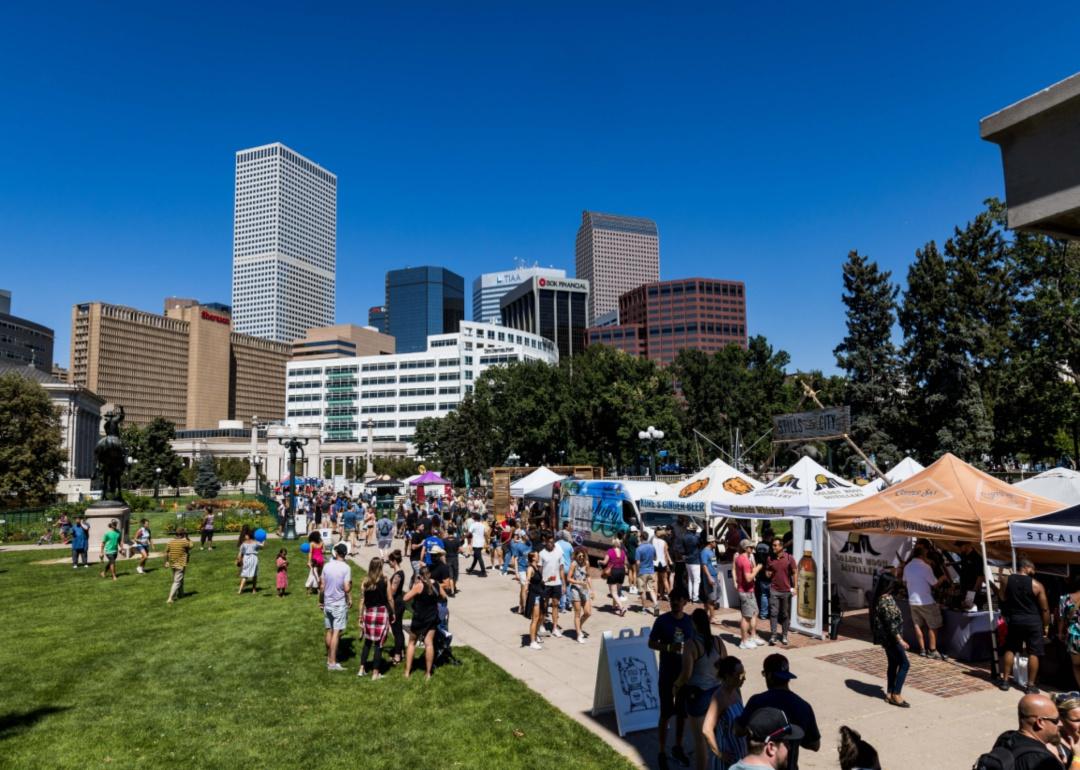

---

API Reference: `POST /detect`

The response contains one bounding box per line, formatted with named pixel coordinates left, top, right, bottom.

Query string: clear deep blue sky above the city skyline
left=0, top=2, right=1080, bottom=369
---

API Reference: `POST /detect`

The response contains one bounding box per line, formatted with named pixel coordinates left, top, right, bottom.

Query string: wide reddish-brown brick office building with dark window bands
left=586, top=278, right=746, bottom=366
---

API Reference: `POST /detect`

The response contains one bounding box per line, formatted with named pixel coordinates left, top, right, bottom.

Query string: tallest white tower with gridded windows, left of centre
left=232, top=141, right=337, bottom=342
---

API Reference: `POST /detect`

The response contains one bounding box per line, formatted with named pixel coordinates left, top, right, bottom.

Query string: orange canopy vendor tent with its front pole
left=827, top=454, right=1061, bottom=657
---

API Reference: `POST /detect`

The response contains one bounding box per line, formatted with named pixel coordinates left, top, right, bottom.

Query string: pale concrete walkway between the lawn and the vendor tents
left=345, top=539, right=1036, bottom=770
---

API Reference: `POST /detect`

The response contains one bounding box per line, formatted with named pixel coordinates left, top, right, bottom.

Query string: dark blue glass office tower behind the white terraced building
left=387, top=267, right=465, bottom=353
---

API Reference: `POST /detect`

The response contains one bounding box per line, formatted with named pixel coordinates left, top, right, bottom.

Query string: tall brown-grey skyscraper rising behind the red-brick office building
left=575, top=212, right=660, bottom=323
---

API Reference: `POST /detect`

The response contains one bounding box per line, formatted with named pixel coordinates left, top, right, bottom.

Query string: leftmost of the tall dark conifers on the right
left=833, top=252, right=903, bottom=467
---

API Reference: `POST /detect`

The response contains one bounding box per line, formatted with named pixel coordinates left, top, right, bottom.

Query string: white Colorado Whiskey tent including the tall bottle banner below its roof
left=710, top=457, right=873, bottom=638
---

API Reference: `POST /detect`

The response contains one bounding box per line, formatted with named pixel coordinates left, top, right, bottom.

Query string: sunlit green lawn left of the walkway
left=0, top=544, right=630, bottom=770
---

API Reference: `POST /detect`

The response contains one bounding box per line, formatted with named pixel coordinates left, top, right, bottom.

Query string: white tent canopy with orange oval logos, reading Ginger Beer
left=637, top=459, right=761, bottom=540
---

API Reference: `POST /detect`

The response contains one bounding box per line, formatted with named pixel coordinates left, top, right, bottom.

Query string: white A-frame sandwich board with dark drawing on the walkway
left=592, top=629, right=660, bottom=737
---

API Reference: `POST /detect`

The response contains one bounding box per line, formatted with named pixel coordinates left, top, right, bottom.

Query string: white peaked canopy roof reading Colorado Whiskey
left=712, top=457, right=874, bottom=518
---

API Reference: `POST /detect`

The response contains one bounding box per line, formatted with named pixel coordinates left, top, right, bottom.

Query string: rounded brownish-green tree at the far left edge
left=0, top=372, right=67, bottom=508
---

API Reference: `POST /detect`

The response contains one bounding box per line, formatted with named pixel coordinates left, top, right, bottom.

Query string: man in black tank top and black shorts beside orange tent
left=997, top=558, right=1050, bottom=693
